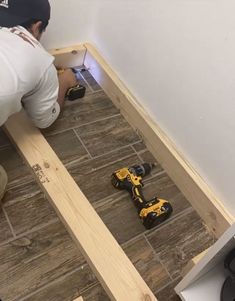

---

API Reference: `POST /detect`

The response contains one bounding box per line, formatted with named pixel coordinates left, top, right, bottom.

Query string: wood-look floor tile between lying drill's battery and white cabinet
left=147, top=211, right=214, bottom=279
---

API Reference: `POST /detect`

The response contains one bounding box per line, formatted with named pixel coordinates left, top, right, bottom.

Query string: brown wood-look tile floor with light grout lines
left=0, top=71, right=214, bottom=301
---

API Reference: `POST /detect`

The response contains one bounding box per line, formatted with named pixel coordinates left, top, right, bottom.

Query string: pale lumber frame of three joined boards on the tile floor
left=6, top=43, right=234, bottom=301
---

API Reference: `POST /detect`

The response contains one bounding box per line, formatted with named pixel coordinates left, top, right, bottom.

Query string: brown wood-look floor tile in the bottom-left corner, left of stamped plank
left=0, top=222, right=85, bottom=301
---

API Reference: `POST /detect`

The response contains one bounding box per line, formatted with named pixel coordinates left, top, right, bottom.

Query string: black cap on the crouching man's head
left=0, top=0, right=51, bottom=27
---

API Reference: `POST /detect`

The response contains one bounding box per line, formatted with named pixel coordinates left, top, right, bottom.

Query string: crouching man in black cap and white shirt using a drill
left=0, top=0, right=77, bottom=200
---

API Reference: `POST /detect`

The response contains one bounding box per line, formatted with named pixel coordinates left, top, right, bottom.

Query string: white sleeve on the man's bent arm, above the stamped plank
left=22, top=65, right=60, bottom=129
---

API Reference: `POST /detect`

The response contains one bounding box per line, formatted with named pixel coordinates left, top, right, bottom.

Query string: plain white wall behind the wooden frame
left=43, top=0, right=235, bottom=215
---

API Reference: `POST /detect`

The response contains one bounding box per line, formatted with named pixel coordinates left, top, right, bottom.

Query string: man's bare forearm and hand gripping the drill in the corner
left=58, top=69, right=78, bottom=108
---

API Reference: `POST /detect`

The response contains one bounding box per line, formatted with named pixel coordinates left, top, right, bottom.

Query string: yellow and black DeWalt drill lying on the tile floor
left=111, top=163, right=173, bottom=229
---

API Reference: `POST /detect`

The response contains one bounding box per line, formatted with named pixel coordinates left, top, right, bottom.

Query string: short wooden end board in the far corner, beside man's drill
left=49, top=45, right=86, bottom=69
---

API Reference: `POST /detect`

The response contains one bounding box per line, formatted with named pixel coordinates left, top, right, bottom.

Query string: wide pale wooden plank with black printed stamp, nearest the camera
left=5, top=112, right=156, bottom=301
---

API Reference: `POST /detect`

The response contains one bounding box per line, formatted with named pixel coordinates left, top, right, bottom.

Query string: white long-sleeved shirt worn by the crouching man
left=0, top=26, right=60, bottom=128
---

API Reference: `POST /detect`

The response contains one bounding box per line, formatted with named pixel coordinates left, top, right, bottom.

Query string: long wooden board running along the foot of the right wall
left=84, top=44, right=234, bottom=237
